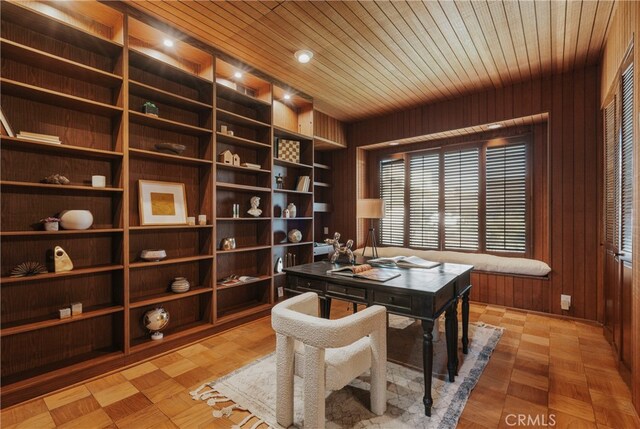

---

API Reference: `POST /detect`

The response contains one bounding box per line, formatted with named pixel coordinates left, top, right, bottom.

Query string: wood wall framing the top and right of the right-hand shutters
left=600, top=2, right=640, bottom=413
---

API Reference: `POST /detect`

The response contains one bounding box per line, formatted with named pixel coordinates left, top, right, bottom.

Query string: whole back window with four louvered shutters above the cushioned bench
left=380, top=135, right=532, bottom=256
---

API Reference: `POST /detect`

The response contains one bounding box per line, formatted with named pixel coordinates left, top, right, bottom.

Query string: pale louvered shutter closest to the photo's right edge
left=620, top=64, right=633, bottom=256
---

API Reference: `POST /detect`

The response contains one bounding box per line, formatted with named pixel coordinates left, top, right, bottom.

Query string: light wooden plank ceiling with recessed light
left=129, top=0, right=614, bottom=121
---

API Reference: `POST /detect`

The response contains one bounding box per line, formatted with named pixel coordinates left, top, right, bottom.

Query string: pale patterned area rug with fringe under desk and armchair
left=191, top=323, right=502, bottom=429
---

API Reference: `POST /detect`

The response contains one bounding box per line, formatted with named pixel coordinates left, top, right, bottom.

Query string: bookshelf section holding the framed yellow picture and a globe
left=124, top=18, right=215, bottom=353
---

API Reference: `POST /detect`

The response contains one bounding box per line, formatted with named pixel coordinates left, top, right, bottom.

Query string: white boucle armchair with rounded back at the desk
left=271, top=292, right=387, bottom=428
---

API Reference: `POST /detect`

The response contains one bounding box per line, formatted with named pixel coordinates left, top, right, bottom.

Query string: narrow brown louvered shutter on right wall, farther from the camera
left=604, top=98, right=619, bottom=246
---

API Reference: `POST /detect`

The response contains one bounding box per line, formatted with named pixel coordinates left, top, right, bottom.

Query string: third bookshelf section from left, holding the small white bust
left=215, top=59, right=273, bottom=323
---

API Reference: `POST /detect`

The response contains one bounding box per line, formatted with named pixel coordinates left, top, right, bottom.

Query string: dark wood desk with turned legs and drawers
left=284, top=261, right=473, bottom=416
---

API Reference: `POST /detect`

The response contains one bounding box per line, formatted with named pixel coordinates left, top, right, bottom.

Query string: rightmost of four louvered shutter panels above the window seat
left=485, top=143, right=527, bottom=252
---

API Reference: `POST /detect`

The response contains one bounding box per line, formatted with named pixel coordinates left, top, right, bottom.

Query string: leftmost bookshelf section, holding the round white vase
left=0, top=2, right=127, bottom=405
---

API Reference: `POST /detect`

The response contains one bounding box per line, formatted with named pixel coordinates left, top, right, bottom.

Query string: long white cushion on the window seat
left=356, top=247, right=551, bottom=276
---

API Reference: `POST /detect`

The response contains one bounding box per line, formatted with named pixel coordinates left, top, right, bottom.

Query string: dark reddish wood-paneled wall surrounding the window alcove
left=335, top=67, right=602, bottom=320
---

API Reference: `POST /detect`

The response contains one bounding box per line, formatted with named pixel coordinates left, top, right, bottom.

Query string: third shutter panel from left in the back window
left=444, top=147, right=480, bottom=250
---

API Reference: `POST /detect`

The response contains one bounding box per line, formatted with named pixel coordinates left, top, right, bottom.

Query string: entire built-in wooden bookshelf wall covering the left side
left=0, top=2, right=329, bottom=406
